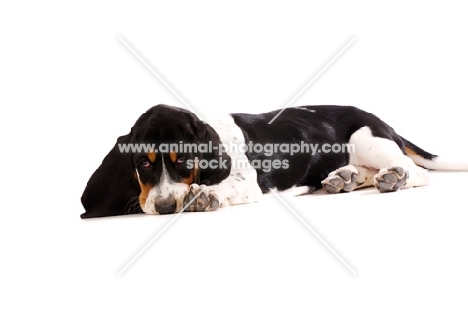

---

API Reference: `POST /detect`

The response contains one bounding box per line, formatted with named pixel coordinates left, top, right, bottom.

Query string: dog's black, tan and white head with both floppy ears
left=81, top=105, right=230, bottom=218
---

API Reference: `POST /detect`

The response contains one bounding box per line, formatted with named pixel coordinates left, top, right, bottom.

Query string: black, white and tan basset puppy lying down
left=81, top=105, right=468, bottom=218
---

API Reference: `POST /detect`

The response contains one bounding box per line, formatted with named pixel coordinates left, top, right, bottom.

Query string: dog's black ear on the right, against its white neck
left=197, top=121, right=231, bottom=186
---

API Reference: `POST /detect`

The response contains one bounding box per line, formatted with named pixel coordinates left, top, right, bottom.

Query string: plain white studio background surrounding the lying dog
left=0, top=1, right=468, bottom=310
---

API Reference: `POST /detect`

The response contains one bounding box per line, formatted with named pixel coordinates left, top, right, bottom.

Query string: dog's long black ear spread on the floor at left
left=81, top=133, right=141, bottom=218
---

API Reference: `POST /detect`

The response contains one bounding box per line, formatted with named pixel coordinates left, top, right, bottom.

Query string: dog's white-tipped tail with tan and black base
left=400, top=136, right=468, bottom=171
